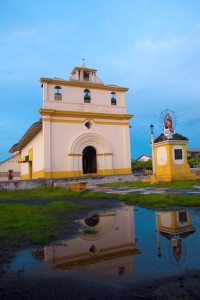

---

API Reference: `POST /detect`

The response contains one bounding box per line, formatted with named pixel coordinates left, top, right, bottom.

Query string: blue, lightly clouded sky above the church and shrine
left=0, top=0, right=200, bottom=161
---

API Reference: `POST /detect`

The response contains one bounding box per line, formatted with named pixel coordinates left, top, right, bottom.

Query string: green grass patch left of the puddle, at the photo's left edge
left=0, top=201, right=81, bottom=245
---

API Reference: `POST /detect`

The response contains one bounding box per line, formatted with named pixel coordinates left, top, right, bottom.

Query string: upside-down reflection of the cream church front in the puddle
left=35, top=207, right=139, bottom=275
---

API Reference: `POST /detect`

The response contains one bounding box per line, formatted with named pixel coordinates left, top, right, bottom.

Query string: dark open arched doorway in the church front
left=82, top=146, right=97, bottom=174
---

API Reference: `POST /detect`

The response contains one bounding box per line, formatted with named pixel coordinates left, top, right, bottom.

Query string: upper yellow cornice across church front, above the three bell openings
left=40, top=78, right=128, bottom=92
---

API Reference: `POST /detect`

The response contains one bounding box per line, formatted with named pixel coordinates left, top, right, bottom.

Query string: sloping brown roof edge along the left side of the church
left=9, top=119, right=42, bottom=153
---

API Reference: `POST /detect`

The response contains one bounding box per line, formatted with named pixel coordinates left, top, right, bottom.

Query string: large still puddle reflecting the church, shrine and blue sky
left=9, top=206, right=200, bottom=283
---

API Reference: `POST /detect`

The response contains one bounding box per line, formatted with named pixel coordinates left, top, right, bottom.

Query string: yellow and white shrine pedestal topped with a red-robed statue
left=151, top=110, right=197, bottom=182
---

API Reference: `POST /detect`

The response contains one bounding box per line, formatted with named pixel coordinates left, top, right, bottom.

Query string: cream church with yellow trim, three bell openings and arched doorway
left=10, top=64, right=132, bottom=179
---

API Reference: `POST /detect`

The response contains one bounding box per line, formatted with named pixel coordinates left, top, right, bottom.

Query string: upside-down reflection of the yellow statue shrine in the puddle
left=156, top=210, right=195, bottom=264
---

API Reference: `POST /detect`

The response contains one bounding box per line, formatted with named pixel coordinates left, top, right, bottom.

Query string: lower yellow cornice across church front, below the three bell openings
left=38, top=108, right=133, bottom=120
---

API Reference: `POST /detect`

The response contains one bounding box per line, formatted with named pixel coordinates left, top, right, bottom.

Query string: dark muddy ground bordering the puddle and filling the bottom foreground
left=0, top=199, right=200, bottom=300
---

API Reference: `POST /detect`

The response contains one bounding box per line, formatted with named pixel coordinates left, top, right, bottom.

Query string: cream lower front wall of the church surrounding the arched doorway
left=43, top=118, right=131, bottom=171
